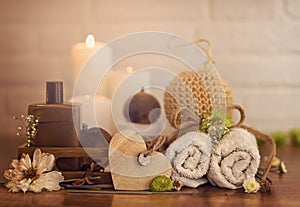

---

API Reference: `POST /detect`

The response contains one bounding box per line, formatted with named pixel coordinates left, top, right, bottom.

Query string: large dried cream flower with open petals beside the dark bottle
left=4, top=149, right=64, bottom=193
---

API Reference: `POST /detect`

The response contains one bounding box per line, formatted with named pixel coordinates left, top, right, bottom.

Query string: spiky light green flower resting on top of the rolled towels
left=201, top=109, right=233, bottom=144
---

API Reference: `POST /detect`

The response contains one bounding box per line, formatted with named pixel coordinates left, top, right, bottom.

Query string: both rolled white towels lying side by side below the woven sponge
left=165, top=128, right=260, bottom=189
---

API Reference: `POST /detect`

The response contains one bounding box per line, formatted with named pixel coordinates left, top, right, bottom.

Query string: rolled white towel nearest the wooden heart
left=165, top=131, right=212, bottom=188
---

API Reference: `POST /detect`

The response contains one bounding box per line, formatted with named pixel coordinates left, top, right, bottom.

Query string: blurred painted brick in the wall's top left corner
left=0, top=0, right=91, bottom=26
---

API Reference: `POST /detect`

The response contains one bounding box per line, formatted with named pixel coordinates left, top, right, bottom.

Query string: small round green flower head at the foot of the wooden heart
left=149, top=175, right=173, bottom=192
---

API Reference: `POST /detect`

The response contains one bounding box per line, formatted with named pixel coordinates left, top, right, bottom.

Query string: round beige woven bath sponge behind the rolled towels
left=164, top=64, right=233, bottom=128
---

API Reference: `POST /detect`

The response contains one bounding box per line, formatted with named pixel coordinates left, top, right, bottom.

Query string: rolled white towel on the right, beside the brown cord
left=207, top=128, right=260, bottom=189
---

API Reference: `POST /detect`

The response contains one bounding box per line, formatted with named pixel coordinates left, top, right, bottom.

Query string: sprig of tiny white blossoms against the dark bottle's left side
left=13, top=115, right=39, bottom=147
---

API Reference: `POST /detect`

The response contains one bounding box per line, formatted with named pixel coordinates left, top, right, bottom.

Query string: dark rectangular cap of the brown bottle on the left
left=46, top=81, right=64, bottom=104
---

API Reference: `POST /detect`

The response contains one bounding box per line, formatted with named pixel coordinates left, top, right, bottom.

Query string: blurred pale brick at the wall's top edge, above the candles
left=94, top=0, right=208, bottom=23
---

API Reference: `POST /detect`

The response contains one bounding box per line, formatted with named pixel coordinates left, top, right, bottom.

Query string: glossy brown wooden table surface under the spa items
left=0, top=146, right=300, bottom=207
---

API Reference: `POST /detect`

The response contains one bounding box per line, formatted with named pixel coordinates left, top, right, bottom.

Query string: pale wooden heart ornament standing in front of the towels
left=109, top=130, right=172, bottom=190
